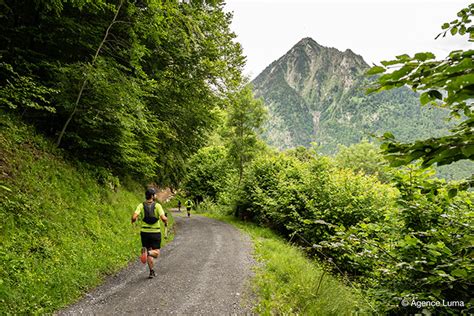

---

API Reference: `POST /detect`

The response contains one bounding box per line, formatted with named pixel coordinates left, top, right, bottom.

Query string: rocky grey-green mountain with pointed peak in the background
left=252, top=38, right=447, bottom=153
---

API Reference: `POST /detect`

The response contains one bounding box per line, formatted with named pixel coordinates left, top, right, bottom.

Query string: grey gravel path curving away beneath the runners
left=58, top=213, right=254, bottom=315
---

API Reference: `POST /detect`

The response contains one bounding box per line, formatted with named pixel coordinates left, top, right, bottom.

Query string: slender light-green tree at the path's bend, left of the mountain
left=226, top=85, right=266, bottom=184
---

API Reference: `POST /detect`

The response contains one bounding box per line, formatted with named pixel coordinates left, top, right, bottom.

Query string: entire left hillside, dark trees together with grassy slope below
left=0, top=0, right=248, bottom=314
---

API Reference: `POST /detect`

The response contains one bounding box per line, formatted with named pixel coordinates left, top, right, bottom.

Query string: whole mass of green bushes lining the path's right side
left=187, top=143, right=474, bottom=313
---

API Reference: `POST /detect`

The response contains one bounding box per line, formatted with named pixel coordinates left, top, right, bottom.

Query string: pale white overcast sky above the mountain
left=225, top=0, right=474, bottom=79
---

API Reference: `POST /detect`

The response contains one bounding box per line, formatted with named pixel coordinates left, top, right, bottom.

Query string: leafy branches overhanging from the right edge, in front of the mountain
left=367, top=4, right=474, bottom=183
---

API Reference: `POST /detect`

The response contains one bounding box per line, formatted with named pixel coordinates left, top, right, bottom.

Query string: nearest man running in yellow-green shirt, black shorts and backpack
left=132, top=188, right=168, bottom=279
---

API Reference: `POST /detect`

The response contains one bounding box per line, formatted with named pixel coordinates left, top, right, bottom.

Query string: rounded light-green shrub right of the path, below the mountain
left=238, top=154, right=397, bottom=260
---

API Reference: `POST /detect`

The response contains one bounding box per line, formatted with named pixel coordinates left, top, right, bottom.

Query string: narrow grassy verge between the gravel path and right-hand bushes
left=204, top=214, right=370, bottom=315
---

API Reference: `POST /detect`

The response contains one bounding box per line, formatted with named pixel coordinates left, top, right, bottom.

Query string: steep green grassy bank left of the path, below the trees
left=0, top=113, right=172, bottom=315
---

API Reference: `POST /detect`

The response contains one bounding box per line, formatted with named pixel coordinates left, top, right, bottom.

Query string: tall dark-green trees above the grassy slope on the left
left=0, top=0, right=244, bottom=185
